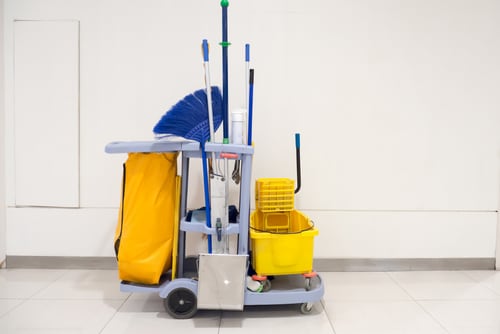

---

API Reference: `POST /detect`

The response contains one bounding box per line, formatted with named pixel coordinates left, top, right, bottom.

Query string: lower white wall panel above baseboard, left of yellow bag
left=7, top=208, right=118, bottom=256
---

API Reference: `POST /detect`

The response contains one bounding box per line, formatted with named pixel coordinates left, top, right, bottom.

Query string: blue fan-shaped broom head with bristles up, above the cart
left=153, top=86, right=222, bottom=143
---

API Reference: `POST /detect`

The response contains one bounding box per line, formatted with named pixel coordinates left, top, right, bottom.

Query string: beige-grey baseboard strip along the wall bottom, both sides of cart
left=2, top=255, right=495, bottom=272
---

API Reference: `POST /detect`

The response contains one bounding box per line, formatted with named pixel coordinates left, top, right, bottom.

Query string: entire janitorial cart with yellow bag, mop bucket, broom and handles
left=105, top=0, right=324, bottom=318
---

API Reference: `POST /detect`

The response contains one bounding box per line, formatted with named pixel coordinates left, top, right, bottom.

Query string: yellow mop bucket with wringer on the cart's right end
left=250, top=178, right=319, bottom=277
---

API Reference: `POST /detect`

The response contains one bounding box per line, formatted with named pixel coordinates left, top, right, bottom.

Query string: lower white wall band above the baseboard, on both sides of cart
left=7, top=208, right=497, bottom=259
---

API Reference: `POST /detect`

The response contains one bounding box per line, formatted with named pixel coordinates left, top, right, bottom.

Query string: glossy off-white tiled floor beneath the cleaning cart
left=0, top=269, right=500, bottom=334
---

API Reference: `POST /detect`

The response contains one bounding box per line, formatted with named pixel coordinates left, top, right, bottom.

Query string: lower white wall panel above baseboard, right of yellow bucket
left=305, top=211, right=497, bottom=259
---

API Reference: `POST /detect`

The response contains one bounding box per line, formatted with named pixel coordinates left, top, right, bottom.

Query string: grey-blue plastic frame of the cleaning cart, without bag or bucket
left=105, top=140, right=324, bottom=318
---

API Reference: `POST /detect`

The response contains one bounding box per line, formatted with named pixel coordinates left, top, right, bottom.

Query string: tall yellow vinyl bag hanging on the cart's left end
left=115, top=153, right=180, bottom=284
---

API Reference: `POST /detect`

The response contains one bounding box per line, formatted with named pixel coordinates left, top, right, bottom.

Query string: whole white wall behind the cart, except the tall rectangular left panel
left=5, top=0, right=500, bottom=258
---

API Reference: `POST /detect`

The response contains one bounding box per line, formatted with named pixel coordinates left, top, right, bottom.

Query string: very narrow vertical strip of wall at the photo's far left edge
left=0, top=0, right=6, bottom=263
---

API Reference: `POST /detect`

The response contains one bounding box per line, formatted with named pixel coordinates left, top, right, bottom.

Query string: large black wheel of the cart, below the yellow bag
left=163, top=288, right=198, bottom=319
